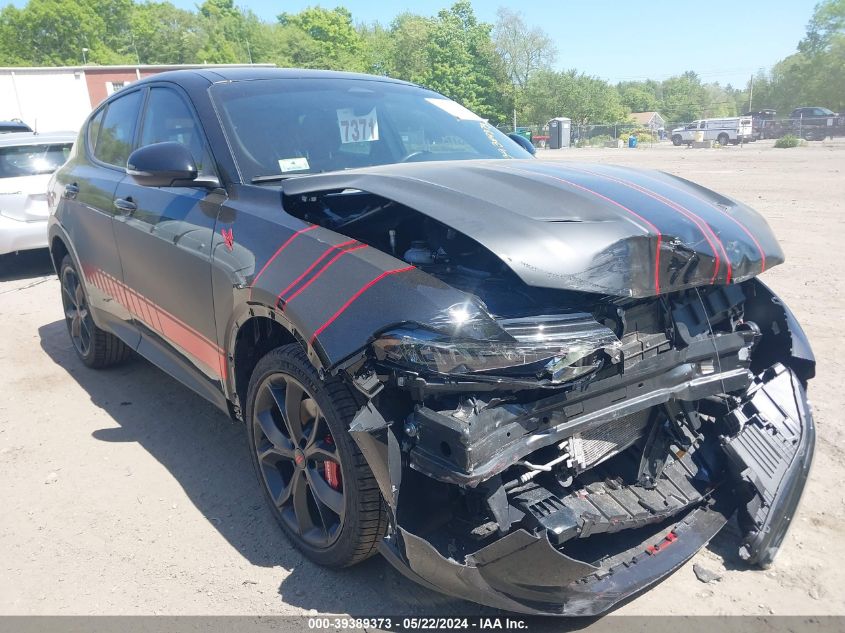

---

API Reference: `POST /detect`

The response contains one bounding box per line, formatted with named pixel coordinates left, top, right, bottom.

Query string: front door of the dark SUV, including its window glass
left=114, top=84, right=231, bottom=401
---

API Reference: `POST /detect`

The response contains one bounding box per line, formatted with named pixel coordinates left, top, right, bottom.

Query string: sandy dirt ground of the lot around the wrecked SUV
left=0, top=139, right=845, bottom=616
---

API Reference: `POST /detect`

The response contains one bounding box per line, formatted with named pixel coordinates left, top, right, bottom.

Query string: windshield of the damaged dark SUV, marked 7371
left=211, top=79, right=531, bottom=182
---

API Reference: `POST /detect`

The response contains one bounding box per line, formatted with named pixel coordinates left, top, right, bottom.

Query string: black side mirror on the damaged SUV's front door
left=126, top=142, right=204, bottom=187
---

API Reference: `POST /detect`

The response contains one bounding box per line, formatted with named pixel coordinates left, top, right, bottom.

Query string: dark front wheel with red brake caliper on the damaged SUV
left=246, top=343, right=387, bottom=568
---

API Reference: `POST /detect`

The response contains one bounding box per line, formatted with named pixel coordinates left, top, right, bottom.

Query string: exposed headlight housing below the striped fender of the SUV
left=373, top=309, right=620, bottom=383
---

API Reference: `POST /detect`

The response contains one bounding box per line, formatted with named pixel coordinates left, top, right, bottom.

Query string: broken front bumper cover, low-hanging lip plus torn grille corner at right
left=365, top=364, right=815, bottom=616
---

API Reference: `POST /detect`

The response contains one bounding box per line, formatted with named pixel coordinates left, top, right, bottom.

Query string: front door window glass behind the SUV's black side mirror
left=139, top=88, right=213, bottom=175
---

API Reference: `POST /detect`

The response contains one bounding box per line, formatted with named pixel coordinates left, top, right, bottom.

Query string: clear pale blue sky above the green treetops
left=13, top=0, right=817, bottom=86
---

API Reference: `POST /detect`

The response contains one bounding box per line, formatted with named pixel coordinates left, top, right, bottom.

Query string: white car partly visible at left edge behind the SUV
left=0, top=132, right=76, bottom=255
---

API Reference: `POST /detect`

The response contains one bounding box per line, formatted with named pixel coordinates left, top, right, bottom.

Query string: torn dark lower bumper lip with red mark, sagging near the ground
left=381, top=506, right=732, bottom=616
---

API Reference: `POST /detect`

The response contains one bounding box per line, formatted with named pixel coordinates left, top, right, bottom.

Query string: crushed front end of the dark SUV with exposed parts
left=343, top=279, right=815, bottom=615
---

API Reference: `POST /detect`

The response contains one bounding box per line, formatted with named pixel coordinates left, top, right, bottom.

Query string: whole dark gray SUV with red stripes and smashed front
left=48, top=69, right=815, bottom=615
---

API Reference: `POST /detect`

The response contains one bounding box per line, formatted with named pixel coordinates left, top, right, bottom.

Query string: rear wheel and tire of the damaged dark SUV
left=59, top=255, right=132, bottom=369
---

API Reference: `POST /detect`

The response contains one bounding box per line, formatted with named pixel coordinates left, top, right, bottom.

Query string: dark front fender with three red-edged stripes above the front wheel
left=241, top=225, right=471, bottom=371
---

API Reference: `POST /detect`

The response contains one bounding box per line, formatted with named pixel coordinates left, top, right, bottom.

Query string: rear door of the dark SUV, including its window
left=55, top=90, right=143, bottom=348
